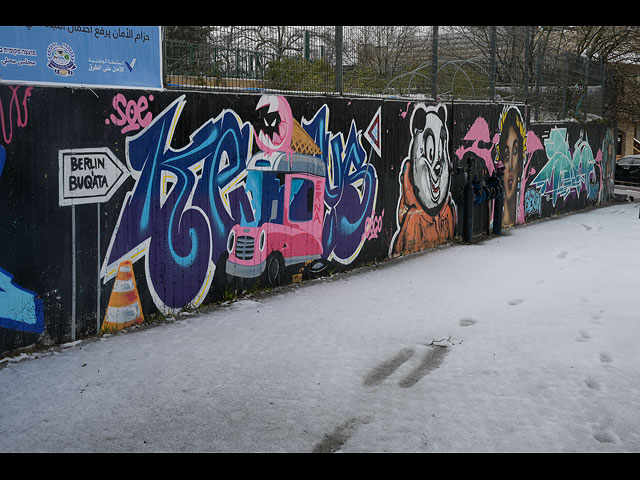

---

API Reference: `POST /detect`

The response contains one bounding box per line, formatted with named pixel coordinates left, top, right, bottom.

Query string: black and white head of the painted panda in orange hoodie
left=410, top=105, right=451, bottom=216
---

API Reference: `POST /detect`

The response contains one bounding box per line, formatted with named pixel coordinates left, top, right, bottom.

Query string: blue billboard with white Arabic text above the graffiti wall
left=0, top=26, right=162, bottom=89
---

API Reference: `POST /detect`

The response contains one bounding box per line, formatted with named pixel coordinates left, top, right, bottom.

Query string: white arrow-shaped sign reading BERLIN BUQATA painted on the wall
left=58, top=147, right=130, bottom=206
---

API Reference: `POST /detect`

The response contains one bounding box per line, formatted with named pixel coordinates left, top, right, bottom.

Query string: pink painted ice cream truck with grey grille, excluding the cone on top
left=226, top=152, right=325, bottom=285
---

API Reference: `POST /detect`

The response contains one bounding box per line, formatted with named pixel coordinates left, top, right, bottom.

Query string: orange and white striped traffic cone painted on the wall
left=101, top=260, right=144, bottom=333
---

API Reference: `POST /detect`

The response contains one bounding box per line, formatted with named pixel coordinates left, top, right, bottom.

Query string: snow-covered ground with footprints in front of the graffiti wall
left=0, top=197, right=640, bottom=452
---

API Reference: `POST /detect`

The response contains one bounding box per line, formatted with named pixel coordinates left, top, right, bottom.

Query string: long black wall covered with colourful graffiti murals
left=0, top=85, right=615, bottom=353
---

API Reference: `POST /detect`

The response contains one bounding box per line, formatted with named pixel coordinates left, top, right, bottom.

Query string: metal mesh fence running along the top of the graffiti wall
left=164, top=26, right=615, bottom=121
